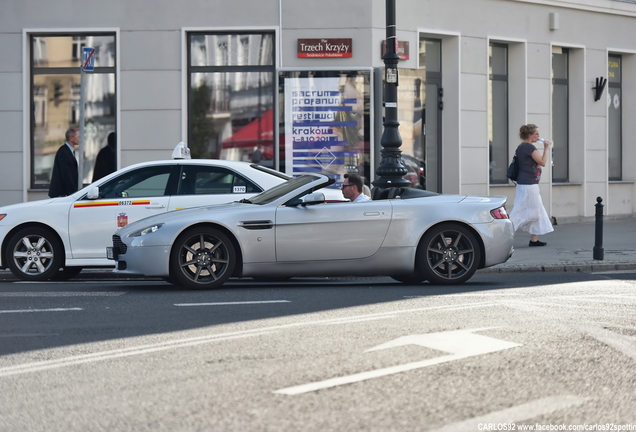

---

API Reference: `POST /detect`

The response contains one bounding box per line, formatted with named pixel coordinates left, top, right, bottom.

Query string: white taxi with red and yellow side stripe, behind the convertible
left=0, top=143, right=298, bottom=281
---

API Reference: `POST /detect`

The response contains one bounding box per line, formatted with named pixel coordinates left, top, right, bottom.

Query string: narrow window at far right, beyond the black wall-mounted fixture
left=607, top=55, right=623, bottom=181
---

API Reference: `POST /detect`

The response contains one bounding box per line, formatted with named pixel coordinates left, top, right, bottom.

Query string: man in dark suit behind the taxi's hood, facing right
left=49, top=128, right=79, bottom=198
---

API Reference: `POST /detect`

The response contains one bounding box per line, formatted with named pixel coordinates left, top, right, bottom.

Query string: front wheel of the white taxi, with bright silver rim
left=6, top=227, right=64, bottom=281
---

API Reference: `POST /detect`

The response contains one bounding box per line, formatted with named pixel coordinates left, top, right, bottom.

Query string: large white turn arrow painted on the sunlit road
left=274, top=328, right=521, bottom=396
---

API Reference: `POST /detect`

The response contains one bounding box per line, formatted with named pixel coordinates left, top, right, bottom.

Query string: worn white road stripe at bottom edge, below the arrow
left=432, top=395, right=588, bottom=432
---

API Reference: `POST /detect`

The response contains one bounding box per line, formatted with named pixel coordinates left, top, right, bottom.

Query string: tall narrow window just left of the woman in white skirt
left=488, top=43, right=512, bottom=184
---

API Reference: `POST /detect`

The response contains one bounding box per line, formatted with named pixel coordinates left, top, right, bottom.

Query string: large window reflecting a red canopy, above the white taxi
left=188, top=32, right=275, bottom=167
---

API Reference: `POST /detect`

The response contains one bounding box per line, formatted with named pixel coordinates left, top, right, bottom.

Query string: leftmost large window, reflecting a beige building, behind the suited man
left=30, top=34, right=117, bottom=189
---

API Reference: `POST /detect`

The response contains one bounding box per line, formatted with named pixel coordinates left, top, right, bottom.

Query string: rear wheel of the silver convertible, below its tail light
left=417, top=223, right=481, bottom=285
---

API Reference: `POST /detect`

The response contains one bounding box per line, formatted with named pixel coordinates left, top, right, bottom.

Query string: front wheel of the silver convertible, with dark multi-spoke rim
left=168, top=227, right=236, bottom=289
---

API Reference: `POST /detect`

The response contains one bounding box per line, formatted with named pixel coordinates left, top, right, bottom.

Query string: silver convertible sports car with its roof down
left=107, top=174, right=514, bottom=289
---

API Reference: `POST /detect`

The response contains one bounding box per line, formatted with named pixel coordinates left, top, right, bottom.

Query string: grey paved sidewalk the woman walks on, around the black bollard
left=0, top=217, right=636, bottom=281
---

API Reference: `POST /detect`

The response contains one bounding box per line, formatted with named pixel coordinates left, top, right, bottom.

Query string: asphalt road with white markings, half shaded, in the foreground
left=0, top=271, right=636, bottom=432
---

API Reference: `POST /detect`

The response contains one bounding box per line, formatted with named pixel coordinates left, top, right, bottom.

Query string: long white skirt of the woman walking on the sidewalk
left=510, top=184, right=554, bottom=235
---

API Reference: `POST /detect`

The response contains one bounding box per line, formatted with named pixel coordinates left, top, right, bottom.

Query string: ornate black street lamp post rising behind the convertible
left=373, top=0, right=410, bottom=199
